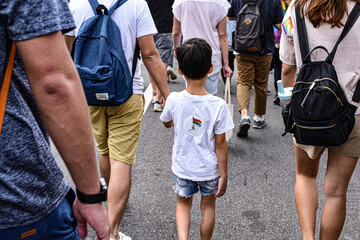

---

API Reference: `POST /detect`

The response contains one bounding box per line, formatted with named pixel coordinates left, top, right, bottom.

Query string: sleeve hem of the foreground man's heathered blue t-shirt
left=9, top=20, right=76, bottom=41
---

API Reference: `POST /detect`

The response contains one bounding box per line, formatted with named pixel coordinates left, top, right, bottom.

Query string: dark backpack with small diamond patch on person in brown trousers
left=233, top=0, right=266, bottom=55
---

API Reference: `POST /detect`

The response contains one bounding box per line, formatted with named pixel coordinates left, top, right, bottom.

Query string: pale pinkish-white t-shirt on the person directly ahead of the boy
left=173, top=0, right=230, bottom=76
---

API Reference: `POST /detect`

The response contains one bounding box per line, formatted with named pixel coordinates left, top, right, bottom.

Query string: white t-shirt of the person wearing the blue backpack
left=66, top=0, right=157, bottom=94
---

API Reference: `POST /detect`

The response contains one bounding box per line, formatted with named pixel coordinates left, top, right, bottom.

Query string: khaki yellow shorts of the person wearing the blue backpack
left=89, top=94, right=145, bottom=164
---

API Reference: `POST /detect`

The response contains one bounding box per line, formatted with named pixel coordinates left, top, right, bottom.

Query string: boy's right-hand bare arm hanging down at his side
left=215, top=133, right=228, bottom=197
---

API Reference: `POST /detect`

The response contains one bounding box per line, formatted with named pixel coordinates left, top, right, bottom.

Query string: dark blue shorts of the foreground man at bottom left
left=0, top=198, right=80, bottom=240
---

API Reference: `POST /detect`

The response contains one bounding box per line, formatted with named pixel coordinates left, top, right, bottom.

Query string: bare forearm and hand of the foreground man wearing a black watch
left=16, top=32, right=109, bottom=239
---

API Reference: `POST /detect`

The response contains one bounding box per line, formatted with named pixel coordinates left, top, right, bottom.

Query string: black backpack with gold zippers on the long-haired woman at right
left=283, top=3, right=360, bottom=146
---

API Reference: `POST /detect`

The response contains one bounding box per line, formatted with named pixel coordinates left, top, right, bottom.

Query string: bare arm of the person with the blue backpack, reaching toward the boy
left=137, top=35, right=170, bottom=100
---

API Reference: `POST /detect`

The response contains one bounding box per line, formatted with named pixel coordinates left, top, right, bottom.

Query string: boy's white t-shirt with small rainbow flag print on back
left=160, top=90, right=234, bottom=181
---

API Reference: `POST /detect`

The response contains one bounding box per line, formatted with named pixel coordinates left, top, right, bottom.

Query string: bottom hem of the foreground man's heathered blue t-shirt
left=0, top=185, right=70, bottom=229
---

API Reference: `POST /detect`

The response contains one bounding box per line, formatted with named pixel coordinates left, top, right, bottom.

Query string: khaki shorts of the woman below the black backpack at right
left=293, top=115, right=360, bottom=159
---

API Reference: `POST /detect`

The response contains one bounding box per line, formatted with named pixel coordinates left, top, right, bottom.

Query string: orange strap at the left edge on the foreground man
left=0, top=43, right=16, bottom=134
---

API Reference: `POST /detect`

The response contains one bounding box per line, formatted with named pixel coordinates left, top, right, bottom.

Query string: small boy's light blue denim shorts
left=174, top=175, right=220, bottom=197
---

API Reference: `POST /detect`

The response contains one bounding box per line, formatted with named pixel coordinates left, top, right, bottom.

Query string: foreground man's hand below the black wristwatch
left=73, top=199, right=110, bottom=240
